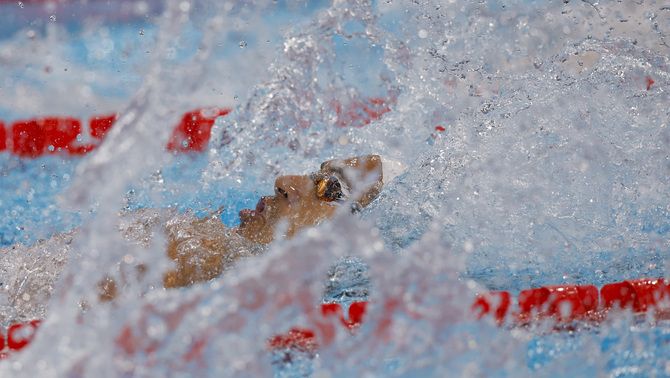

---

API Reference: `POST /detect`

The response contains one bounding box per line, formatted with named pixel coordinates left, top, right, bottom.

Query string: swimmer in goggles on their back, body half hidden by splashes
left=0, top=155, right=394, bottom=312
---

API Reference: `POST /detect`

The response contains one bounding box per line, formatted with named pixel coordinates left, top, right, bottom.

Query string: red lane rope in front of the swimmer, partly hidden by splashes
left=0, top=278, right=670, bottom=360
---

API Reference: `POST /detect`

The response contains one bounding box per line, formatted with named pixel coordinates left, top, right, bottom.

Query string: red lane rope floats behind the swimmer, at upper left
left=0, top=108, right=230, bottom=158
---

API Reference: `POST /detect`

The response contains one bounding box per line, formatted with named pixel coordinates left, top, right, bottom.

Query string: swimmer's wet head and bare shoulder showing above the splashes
left=158, top=155, right=383, bottom=288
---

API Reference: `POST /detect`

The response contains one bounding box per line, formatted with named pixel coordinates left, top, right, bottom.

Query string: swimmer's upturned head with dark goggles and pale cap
left=237, top=155, right=382, bottom=244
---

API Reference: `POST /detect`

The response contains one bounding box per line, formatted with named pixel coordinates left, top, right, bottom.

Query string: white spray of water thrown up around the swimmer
left=0, top=0, right=670, bottom=376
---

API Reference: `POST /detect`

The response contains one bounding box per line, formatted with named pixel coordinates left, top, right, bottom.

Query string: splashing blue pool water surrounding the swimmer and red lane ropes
left=0, top=0, right=670, bottom=377
